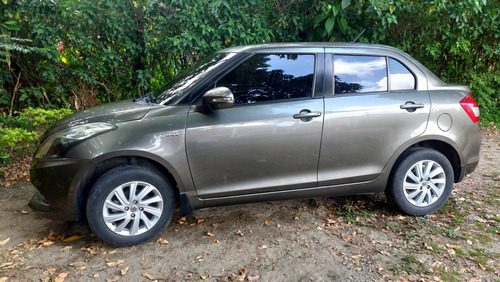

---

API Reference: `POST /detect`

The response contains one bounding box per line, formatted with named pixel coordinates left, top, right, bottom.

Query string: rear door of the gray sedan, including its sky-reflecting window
left=318, top=54, right=431, bottom=185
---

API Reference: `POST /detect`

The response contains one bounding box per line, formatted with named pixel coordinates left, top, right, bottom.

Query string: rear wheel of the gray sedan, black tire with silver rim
left=385, top=149, right=454, bottom=216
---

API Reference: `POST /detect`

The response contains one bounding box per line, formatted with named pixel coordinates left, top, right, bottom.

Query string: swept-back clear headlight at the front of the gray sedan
left=35, top=122, right=116, bottom=159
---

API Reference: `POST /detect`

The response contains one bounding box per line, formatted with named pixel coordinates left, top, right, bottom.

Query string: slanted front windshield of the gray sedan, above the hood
left=151, top=53, right=235, bottom=105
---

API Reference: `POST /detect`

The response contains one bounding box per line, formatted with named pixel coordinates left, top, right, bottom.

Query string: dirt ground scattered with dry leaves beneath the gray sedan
left=0, top=128, right=500, bottom=282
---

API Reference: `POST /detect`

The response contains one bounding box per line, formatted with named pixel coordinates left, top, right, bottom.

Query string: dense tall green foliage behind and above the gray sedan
left=0, top=0, right=500, bottom=123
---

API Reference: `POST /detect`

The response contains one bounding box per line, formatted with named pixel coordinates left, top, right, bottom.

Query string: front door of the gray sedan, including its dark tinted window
left=186, top=52, right=324, bottom=198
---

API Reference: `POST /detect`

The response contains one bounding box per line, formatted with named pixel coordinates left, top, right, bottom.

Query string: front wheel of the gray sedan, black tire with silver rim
left=87, top=165, right=175, bottom=246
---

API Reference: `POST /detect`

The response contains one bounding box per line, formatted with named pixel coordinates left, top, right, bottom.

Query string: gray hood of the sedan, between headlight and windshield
left=41, top=100, right=152, bottom=136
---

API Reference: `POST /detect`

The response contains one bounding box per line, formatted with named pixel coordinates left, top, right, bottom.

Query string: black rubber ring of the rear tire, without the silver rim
left=386, top=148, right=454, bottom=216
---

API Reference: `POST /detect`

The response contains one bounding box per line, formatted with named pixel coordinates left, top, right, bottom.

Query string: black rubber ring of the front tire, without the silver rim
left=87, top=165, right=175, bottom=246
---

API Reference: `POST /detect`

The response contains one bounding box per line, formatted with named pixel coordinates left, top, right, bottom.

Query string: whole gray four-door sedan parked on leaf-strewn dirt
left=30, top=43, right=481, bottom=246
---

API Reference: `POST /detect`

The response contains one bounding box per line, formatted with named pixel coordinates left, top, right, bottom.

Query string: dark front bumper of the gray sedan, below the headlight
left=29, top=159, right=89, bottom=221
